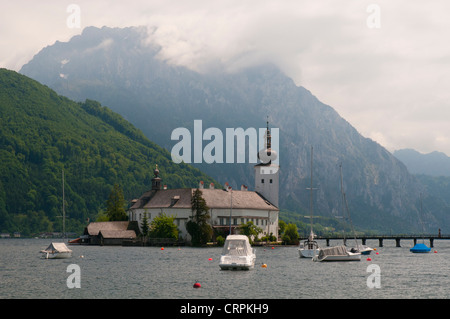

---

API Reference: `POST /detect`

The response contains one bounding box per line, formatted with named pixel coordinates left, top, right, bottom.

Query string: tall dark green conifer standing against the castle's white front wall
left=186, top=188, right=213, bottom=246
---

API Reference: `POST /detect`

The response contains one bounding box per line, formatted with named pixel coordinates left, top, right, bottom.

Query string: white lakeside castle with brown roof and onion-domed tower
left=128, top=123, right=279, bottom=242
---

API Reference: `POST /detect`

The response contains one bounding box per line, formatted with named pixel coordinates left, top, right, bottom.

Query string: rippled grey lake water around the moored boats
left=0, top=239, right=450, bottom=299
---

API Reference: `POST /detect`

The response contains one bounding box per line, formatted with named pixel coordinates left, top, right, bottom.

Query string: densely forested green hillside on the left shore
left=0, top=69, right=218, bottom=235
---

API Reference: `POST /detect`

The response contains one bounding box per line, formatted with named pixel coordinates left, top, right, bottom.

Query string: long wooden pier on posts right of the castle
left=316, top=234, right=450, bottom=248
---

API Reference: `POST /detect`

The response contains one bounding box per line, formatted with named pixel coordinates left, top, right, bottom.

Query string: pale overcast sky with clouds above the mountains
left=0, top=0, right=450, bottom=155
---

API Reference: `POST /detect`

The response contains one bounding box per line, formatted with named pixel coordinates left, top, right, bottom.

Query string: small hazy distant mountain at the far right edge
left=393, top=149, right=450, bottom=177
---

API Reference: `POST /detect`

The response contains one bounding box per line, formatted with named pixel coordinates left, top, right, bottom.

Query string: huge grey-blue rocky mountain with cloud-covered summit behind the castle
left=20, top=27, right=450, bottom=233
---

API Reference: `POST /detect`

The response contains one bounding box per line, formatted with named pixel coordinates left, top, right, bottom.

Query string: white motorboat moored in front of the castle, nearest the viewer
left=219, top=235, right=256, bottom=270
